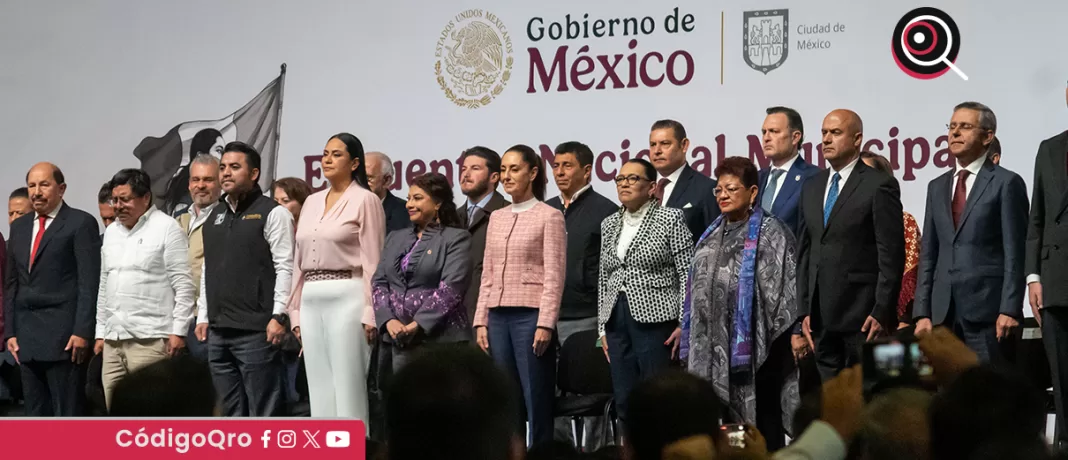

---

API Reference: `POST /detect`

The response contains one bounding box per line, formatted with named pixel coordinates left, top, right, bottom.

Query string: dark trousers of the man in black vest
left=207, top=328, right=286, bottom=417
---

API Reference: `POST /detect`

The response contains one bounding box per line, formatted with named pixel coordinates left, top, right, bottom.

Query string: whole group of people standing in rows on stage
left=3, top=94, right=1068, bottom=448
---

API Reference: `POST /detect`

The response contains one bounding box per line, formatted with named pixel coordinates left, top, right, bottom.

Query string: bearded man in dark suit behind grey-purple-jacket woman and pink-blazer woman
left=457, top=146, right=512, bottom=322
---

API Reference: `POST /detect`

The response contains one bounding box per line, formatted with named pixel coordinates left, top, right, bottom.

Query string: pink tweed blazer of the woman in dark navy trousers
left=474, top=202, right=567, bottom=329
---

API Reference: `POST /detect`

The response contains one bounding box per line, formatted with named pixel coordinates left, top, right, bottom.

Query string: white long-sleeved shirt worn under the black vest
left=197, top=201, right=294, bottom=324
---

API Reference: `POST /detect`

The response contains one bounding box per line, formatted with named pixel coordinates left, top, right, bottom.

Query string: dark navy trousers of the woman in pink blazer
left=487, top=306, right=556, bottom=445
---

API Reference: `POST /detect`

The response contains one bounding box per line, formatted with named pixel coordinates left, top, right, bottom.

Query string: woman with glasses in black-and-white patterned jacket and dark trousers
left=597, top=159, right=693, bottom=421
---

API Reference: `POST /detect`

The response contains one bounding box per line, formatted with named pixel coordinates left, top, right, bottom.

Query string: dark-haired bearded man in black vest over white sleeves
left=197, top=142, right=293, bottom=417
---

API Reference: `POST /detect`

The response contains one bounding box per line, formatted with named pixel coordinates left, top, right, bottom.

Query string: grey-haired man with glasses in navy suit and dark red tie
left=912, top=102, right=1027, bottom=364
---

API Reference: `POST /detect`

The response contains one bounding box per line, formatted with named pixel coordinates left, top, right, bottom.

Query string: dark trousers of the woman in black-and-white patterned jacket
left=604, top=292, right=678, bottom=421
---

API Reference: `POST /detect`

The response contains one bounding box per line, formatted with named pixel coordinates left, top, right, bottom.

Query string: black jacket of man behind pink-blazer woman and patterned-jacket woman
left=545, top=188, right=619, bottom=319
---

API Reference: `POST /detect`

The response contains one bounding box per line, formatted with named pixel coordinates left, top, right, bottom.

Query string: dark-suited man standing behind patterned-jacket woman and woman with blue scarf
left=649, top=120, right=720, bottom=244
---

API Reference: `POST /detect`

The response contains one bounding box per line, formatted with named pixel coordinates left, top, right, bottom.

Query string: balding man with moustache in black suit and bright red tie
left=4, top=163, right=100, bottom=416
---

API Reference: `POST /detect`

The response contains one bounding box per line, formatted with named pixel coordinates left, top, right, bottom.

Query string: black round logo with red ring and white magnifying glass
left=891, top=7, right=968, bottom=80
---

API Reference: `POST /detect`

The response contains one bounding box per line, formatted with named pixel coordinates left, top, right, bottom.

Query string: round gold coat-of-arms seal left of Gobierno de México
left=434, top=10, right=513, bottom=109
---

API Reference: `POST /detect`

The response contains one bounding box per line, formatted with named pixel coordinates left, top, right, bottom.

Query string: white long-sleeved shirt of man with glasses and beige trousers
left=96, top=207, right=194, bottom=340
